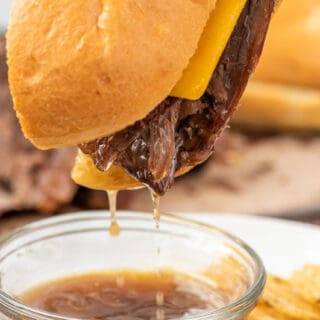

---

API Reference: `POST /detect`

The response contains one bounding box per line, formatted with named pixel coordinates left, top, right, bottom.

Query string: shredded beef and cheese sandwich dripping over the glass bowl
left=7, top=0, right=275, bottom=195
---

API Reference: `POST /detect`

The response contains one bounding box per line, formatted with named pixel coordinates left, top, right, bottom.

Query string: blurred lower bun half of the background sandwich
left=232, top=81, right=320, bottom=131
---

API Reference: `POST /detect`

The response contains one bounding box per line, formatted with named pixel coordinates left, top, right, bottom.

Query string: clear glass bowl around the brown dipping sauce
left=0, top=212, right=266, bottom=320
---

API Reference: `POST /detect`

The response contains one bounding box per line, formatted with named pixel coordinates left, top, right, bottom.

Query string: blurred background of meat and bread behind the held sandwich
left=0, top=0, right=320, bottom=232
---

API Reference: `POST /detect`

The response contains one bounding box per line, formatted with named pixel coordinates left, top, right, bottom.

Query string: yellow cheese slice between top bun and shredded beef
left=170, top=0, right=247, bottom=100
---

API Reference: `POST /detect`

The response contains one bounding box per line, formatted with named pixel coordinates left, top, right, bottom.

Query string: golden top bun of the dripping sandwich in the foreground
left=7, top=0, right=215, bottom=148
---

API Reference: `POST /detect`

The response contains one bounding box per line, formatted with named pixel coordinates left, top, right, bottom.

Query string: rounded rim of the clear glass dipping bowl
left=0, top=210, right=266, bottom=320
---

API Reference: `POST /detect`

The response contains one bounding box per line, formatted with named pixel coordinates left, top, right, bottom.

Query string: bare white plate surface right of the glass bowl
left=184, top=214, right=320, bottom=277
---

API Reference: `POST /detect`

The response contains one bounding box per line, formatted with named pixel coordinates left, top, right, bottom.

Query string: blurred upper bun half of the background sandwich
left=254, top=0, right=320, bottom=88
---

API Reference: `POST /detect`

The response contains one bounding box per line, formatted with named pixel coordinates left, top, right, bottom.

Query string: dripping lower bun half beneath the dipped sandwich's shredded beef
left=71, top=151, right=192, bottom=191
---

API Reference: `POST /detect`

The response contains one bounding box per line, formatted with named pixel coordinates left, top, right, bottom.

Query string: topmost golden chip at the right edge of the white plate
left=289, top=265, right=320, bottom=306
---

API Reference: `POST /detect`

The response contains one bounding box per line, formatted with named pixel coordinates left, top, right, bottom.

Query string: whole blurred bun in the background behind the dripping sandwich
left=233, top=0, right=320, bottom=131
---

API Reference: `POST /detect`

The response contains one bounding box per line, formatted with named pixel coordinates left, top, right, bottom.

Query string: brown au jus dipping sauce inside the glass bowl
left=21, top=270, right=229, bottom=320
